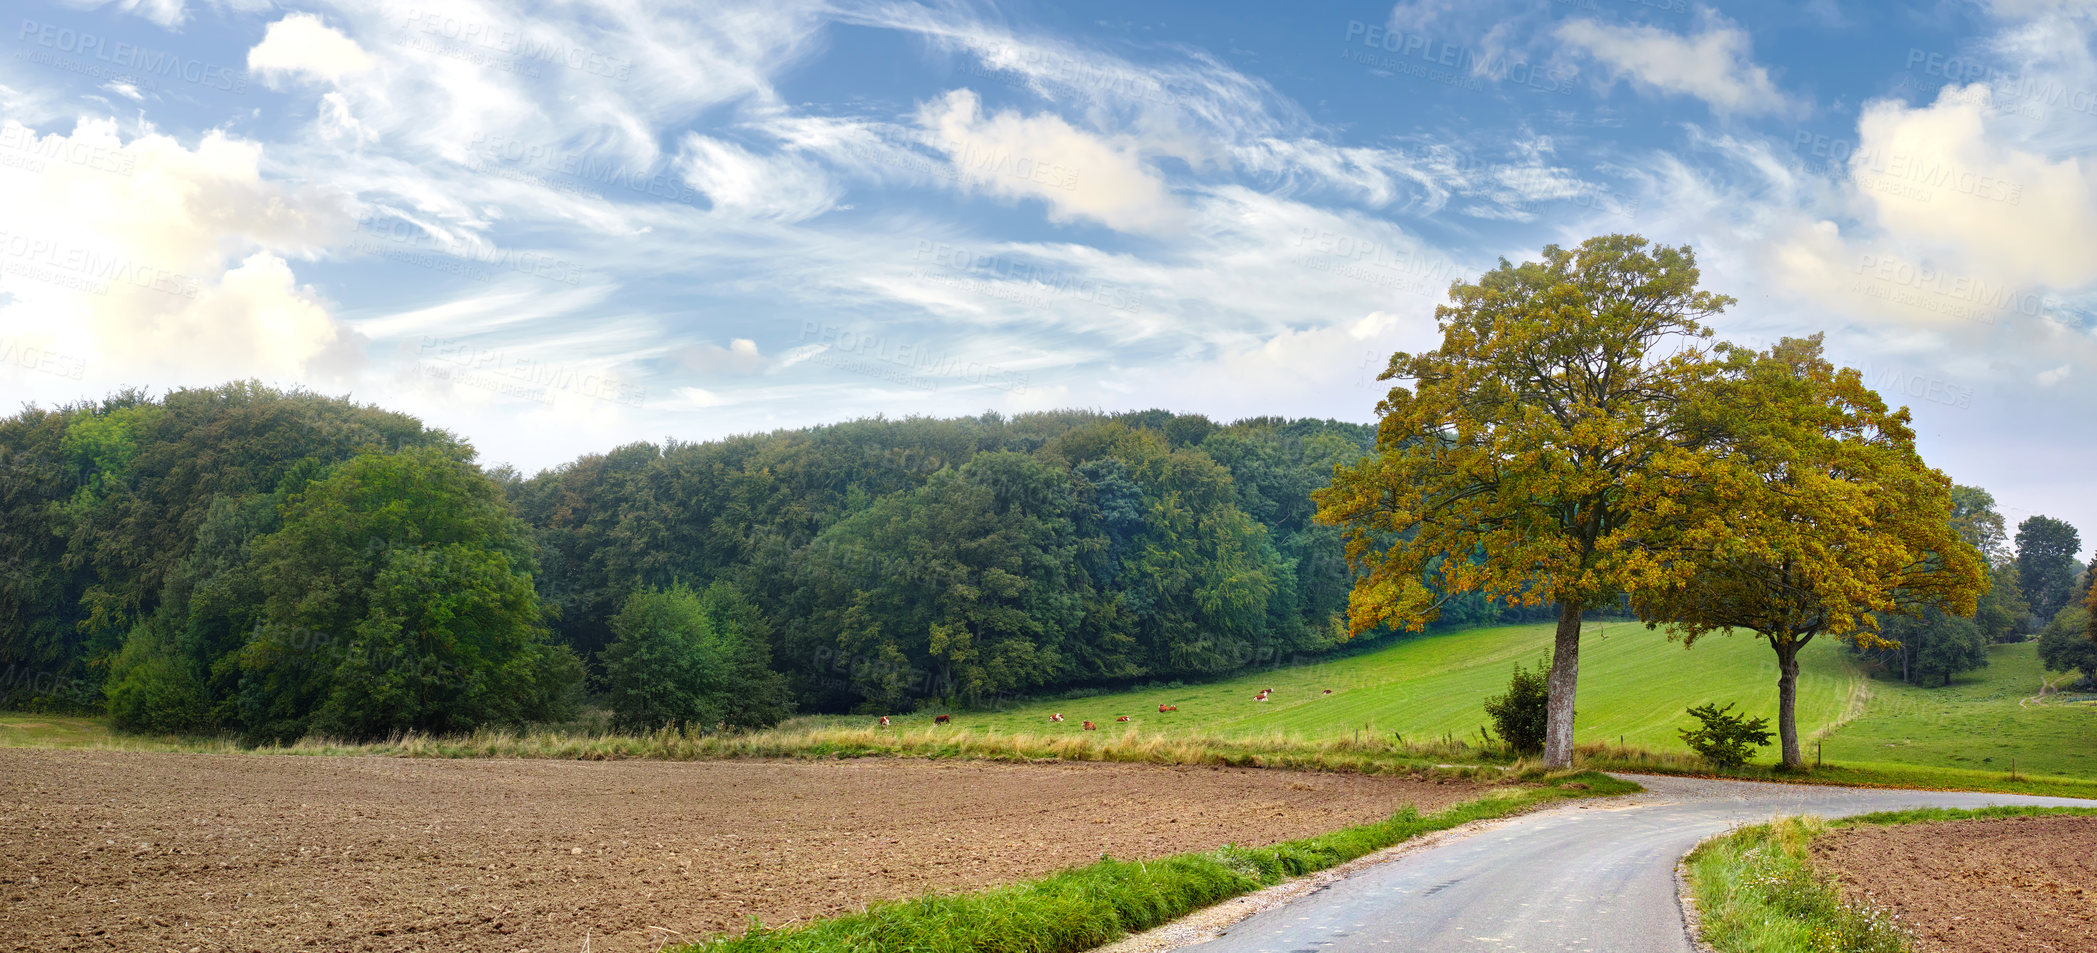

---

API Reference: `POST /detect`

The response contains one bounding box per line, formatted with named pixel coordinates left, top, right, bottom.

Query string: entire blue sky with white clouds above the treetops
left=0, top=0, right=2097, bottom=546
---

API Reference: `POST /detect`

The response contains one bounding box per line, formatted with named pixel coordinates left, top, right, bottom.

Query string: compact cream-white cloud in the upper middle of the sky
left=918, top=90, right=1181, bottom=231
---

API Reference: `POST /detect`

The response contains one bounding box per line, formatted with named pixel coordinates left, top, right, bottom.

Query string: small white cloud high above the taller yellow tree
left=1558, top=17, right=1791, bottom=115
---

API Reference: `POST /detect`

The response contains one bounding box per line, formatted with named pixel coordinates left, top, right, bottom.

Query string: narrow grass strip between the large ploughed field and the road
left=684, top=772, right=1640, bottom=953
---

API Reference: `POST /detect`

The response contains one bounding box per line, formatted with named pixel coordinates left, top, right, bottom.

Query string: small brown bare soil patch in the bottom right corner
left=1812, top=817, right=2097, bottom=953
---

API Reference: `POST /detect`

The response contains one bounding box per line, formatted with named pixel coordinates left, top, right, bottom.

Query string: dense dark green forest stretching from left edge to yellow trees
left=0, top=384, right=1545, bottom=741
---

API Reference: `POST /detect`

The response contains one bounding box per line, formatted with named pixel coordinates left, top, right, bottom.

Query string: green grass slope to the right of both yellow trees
left=1824, top=642, right=2097, bottom=777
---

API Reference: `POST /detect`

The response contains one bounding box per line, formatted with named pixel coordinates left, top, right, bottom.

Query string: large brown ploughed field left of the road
left=0, top=749, right=1480, bottom=953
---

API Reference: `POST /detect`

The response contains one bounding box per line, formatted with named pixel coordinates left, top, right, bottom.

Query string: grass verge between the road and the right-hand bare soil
left=1682, top=806, right=2097, bottom=953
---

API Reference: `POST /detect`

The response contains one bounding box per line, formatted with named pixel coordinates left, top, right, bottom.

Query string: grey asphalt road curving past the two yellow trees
left=1183, top=775, right=2097, bottom=953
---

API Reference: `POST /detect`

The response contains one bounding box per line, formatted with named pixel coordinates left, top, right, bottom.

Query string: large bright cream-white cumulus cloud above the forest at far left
left=0, top=120, right=348, bottom=382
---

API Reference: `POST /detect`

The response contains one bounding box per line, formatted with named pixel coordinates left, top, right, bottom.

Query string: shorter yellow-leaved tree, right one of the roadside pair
left=1631, top=334, right=1988, bottom=768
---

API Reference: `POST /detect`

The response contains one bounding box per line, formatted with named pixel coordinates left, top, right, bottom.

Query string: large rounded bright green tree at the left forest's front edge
left=239, top=447, right=581, bottom=739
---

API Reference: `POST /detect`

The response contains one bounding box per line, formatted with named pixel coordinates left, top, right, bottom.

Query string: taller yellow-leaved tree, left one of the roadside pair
left=1317, top=235, right=1732, bottom=766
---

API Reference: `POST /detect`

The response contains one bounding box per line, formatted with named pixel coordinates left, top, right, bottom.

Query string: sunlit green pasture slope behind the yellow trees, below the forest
left=898, top=621, right=1854, bottom=751
